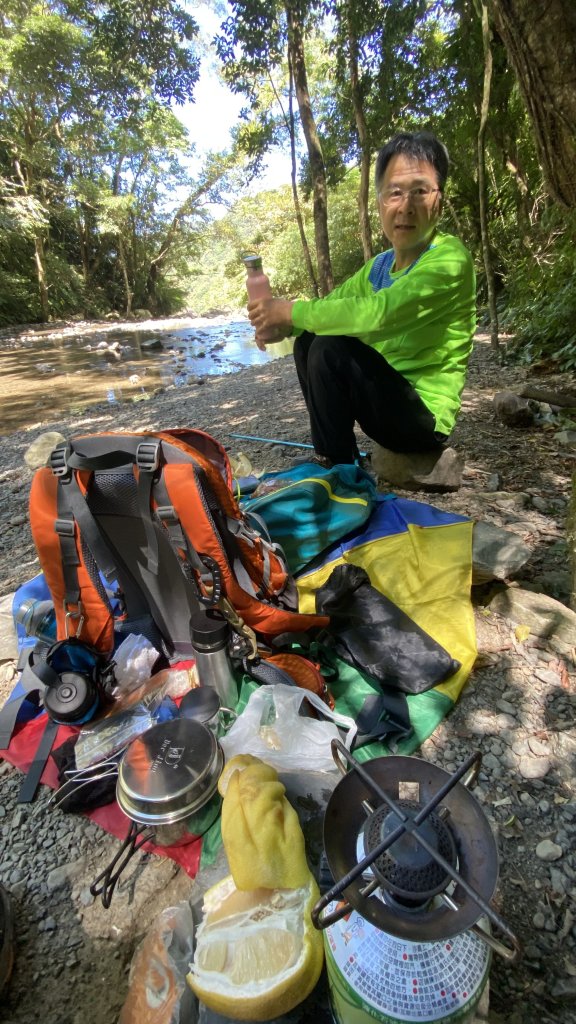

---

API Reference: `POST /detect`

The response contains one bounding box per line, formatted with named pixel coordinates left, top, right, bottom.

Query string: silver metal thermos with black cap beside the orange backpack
left=191, top=609, right=238, bottom=709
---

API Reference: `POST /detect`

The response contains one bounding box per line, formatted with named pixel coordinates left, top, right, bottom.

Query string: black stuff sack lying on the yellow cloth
left=316, top=564, right=460, bottom=694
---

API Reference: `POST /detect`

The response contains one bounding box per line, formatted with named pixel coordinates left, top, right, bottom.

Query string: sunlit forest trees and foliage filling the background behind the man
left=0, top=0, right=576, bottom=369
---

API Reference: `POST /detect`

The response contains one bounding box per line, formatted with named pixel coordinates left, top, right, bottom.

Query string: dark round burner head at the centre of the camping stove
left=364, top=800, right=458, bottom=909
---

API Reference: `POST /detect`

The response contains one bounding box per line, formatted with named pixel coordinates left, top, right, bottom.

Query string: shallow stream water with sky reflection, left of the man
left=0, top=315, right=292, bottom=434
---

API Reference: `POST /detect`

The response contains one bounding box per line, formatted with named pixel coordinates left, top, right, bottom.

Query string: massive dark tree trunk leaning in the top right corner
left=490, top=0, right=576, bottom=207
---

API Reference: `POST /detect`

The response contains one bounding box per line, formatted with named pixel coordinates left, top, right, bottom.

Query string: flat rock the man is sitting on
left=372, top=444, right=464, bottom=494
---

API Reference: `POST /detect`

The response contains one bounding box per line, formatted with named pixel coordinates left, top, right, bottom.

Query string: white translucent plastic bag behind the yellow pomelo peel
left=220, top=683, right=356, bottom=771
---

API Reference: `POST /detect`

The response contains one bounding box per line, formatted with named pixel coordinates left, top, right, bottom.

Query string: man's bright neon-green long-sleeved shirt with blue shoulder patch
left=292, top=232, right=476, bottom=434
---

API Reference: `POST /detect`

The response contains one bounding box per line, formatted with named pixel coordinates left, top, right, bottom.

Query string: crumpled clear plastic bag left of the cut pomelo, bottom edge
left=118, top=900, right=198, bottom=1024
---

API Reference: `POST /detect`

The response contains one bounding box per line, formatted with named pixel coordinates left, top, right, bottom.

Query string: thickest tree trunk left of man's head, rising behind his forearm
left=286, top=3, right=334, bottom=295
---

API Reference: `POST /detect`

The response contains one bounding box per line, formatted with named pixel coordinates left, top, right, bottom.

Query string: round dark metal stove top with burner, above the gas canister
left=313, top=753, right=498, bottom=942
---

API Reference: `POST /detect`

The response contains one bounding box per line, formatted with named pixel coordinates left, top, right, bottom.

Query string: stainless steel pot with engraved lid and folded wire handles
left=90, top=718, right=223, bottom=907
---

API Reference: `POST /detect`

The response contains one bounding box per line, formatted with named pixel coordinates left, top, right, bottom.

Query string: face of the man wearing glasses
left=378, top=154, right=442, bottom=270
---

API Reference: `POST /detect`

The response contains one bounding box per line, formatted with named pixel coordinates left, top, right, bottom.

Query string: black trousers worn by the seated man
left=294, top=332, right=446, bottom=463
